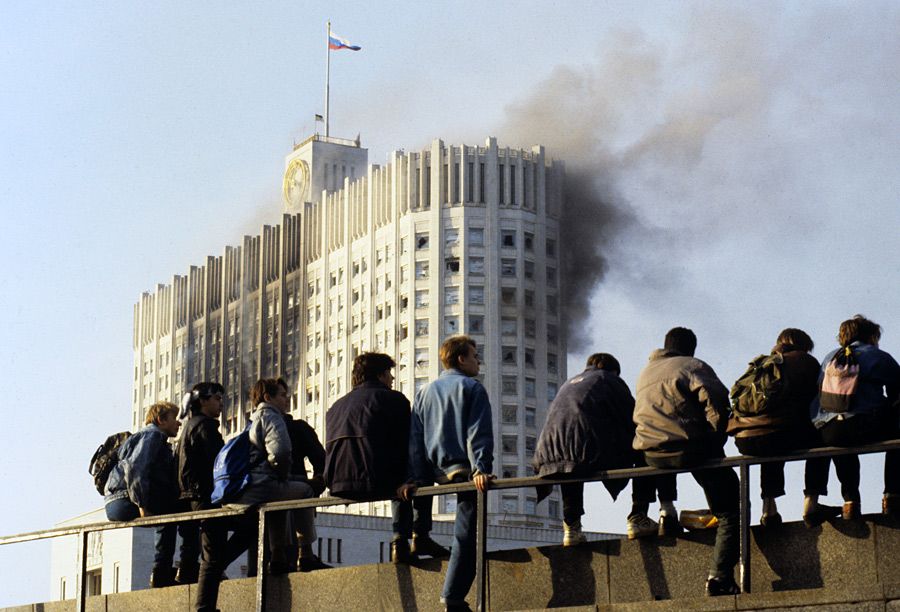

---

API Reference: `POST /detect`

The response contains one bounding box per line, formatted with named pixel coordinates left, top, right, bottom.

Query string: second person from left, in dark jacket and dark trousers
left=175, top=382, right=255, bottom=612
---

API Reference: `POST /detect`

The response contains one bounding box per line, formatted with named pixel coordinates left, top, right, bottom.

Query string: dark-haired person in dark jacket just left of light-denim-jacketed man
left=325, top=353, right=449, bottom=563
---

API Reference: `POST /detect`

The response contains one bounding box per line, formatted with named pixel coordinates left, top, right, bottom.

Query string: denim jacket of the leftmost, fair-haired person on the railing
left=104, top=424, right=178, bottom=514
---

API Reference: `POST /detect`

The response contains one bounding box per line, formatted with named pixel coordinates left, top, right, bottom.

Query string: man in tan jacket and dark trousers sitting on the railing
left=634, top=327, right=740, bottom=595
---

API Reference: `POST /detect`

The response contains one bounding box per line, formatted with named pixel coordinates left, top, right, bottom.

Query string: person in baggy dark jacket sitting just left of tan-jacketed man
left=532, top=353, right=676, bottom=546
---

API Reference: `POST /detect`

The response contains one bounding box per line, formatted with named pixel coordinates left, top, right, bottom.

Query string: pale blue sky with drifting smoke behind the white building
left=0, top=1, right=900, bottom=605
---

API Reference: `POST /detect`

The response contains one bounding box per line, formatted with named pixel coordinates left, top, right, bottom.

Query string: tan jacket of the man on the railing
left=634, top=349, right=729, bottom=455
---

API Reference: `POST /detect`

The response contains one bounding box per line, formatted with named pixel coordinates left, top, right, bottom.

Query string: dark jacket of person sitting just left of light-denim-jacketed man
left=325, top=381, right=410, bottom=497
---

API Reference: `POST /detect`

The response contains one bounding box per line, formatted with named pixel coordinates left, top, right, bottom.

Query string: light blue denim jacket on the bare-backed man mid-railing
left=409, top=369, right=494, bottom=484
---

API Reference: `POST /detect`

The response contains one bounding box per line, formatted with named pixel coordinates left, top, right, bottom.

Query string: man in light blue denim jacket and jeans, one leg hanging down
left=399, top=336, right=494, bottom=610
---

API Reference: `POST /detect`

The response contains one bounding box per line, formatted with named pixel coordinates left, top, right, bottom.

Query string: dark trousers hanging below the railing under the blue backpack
left=191, top=501, right=256, bottom=612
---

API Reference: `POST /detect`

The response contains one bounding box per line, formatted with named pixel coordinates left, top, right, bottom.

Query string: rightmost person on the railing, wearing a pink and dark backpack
left=804, top=315, right=900, bottom=520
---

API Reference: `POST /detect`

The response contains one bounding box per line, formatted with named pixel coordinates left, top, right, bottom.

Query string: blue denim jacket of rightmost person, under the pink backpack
left=810, top=342, right=900, bottom=427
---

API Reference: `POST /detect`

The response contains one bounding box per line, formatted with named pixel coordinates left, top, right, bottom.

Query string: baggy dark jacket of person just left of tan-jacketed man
left=531, top=367, right=634, bottom=497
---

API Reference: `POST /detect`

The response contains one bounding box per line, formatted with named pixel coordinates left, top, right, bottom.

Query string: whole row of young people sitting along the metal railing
left=105, top=315, right=900, bottom=610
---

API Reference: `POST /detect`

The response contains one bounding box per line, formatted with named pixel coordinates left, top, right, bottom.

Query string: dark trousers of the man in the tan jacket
left=647, top=449, right=740, bottom=580
